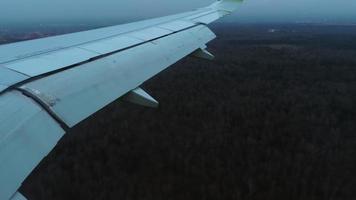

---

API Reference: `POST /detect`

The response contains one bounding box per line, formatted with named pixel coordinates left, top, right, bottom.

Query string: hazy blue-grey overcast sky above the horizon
left=0, top=0, right=356, bottom=25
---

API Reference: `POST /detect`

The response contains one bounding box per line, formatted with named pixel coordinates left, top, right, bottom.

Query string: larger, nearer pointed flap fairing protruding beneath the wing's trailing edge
left=123, top=88, right=159, bottom=108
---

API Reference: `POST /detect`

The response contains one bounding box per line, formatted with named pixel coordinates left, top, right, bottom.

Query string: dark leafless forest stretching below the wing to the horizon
left=13, top=24, right=356, bottom=200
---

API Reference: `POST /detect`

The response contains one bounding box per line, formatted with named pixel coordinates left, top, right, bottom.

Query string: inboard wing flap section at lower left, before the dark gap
left=0, top=91, right=64, bottom=199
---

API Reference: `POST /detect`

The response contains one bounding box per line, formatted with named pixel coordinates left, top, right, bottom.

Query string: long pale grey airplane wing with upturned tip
left=0, top=0, right=240, bottom=200
